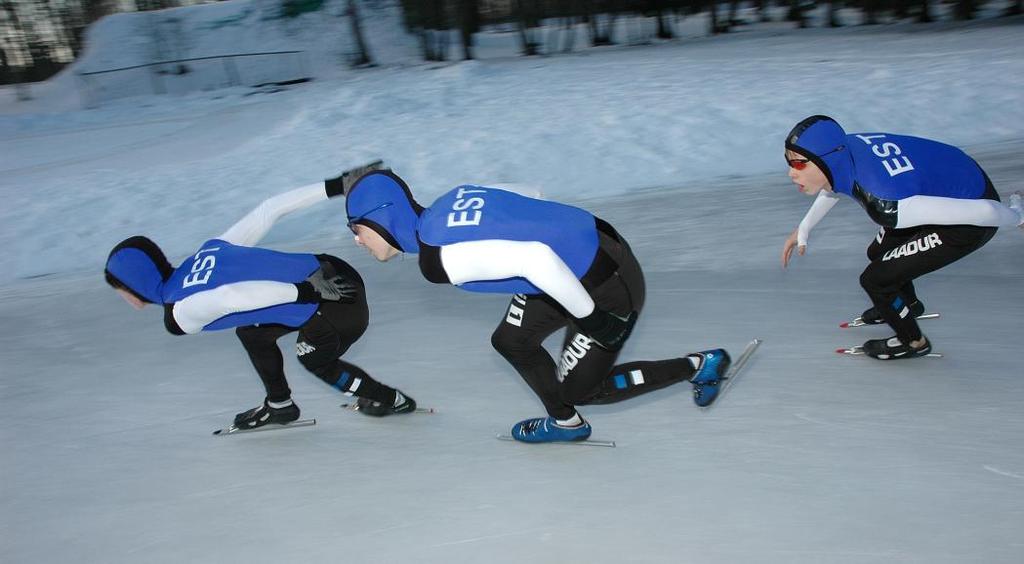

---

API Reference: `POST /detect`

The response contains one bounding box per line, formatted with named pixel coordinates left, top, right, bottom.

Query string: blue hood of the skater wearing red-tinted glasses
left=785, top=116, right=853, bottom=194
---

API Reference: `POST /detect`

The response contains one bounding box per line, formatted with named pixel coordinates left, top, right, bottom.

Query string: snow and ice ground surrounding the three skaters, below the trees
left=0, top=2, right=1024, bottom=563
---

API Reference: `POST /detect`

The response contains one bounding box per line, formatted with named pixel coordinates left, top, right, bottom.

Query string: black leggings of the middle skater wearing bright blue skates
left=490, top=227, right=693, bottom=420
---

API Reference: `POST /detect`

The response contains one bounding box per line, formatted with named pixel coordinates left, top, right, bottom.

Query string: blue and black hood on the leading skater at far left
left=103, top=235, right=174, bottom=304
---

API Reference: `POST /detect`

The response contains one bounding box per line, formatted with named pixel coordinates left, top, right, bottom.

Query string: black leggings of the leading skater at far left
left=236, top=255, right=395, bottom=404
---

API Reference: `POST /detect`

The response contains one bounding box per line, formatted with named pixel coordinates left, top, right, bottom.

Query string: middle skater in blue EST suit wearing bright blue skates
left=345, top=171, right=729, bottom=442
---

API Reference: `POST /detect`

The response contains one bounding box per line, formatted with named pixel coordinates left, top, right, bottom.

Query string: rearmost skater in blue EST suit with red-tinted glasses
left=782, top=116, right=1022, bottom=360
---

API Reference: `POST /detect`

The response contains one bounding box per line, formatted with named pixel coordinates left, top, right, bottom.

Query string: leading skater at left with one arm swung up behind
left=104, top=165, right=416, bottom=429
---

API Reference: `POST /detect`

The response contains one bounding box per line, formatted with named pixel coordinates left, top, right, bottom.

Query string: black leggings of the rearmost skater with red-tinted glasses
left=860, top=225, right=997, bottom=343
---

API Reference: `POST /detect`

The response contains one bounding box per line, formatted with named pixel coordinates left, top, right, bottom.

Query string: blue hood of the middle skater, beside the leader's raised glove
left=345, top=170, right=423, bottom=253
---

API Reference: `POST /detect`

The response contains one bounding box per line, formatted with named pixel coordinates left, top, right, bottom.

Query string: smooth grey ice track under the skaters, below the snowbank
left=0, top=144, right=1024, bottom=563
